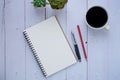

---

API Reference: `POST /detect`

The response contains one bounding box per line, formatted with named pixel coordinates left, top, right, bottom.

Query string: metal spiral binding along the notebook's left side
left=23, top=31, right=47, bottom=76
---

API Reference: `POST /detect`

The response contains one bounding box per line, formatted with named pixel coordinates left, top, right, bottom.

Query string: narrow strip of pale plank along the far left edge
left=0, top=0, right=5, bottom=80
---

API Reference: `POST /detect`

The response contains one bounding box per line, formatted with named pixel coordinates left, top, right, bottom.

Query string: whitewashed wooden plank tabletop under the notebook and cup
left=0, top=0, right=120, bottom=80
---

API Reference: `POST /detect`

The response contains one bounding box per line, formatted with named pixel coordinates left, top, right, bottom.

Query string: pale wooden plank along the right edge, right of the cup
left=107, top=0, right=120, bottom=80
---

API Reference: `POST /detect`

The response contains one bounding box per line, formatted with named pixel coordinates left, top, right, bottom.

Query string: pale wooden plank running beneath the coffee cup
left=88, top=0, right=109, bottom=80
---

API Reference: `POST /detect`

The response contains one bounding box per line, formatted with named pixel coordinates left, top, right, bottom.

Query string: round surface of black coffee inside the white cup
left=86, top=6, right=108, bottom=28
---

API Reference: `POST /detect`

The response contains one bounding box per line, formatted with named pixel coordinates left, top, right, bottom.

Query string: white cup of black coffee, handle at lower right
left=85, top=6, right=110, bottom=30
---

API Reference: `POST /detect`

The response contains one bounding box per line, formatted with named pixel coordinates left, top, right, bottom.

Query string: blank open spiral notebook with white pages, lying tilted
left=23, top=16, right=77, bottom=77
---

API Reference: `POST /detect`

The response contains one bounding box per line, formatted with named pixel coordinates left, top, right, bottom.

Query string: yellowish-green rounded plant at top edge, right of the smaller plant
left=48, top=0, right=68, bottom=9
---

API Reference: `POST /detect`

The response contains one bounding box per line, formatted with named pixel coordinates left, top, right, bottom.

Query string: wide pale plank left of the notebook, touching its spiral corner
left=5, top=0, right=26, bottom=80
